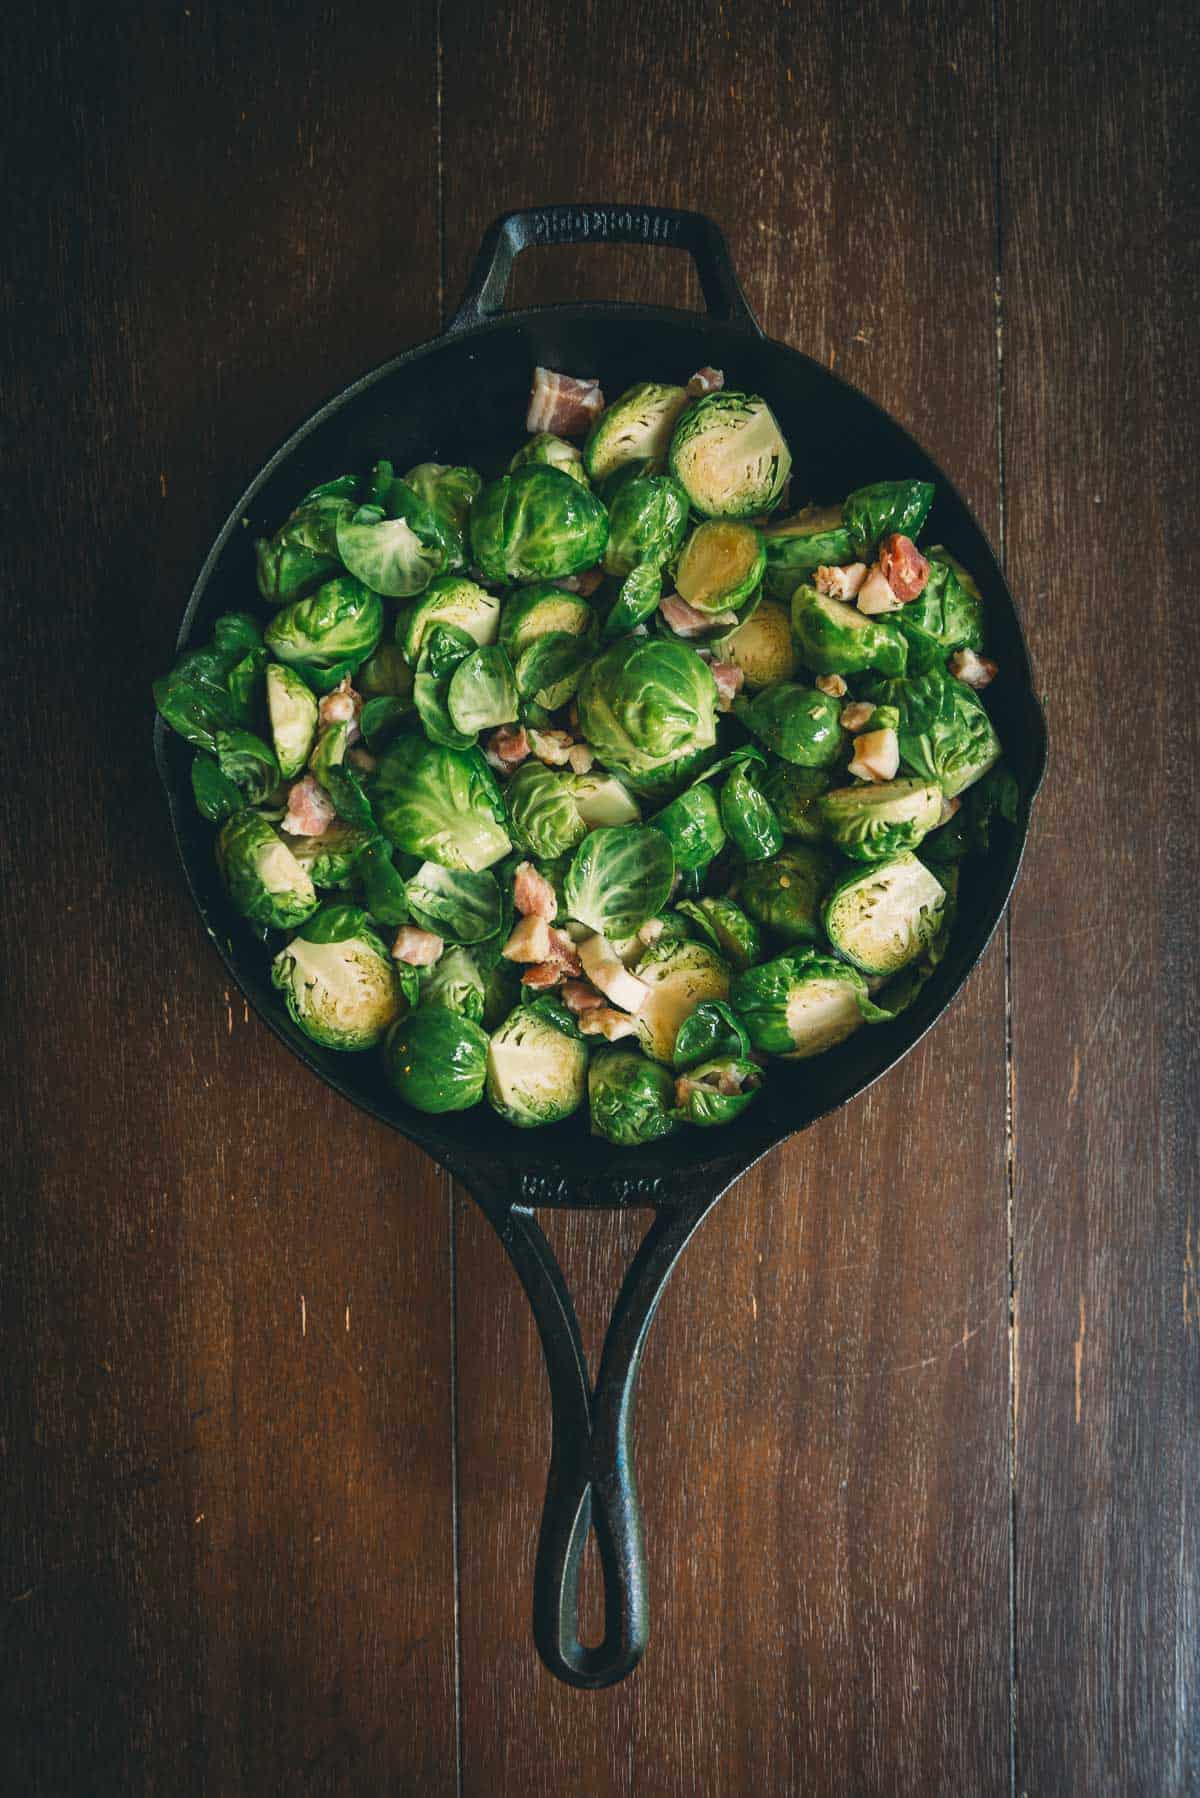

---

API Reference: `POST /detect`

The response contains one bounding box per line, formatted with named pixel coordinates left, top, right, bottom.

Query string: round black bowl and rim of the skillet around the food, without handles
left=157, top=306, right=1045, bottom=1205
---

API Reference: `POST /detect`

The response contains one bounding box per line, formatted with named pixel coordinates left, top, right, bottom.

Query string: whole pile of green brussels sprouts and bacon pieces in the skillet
left=155, top=370, right=1018, bottom=1145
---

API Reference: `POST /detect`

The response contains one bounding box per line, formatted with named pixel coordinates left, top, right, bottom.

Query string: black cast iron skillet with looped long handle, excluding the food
left=155, top=205, right=1045, bottom=1687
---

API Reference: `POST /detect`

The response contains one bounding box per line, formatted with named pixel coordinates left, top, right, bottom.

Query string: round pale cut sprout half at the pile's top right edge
left=667, top=392, right=792, bottom=518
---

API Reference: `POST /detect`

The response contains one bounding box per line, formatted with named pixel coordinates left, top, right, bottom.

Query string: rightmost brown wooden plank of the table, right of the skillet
left=1000, top=0, right=1200, bottom=1794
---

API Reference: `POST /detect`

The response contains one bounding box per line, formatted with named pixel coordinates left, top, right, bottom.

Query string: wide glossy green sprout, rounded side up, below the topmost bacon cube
left=471, top=466, right=608, bottom=581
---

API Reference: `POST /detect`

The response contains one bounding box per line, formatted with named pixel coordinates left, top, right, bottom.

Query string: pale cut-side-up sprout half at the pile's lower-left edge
left=272, top=904, right=403, bottom=1050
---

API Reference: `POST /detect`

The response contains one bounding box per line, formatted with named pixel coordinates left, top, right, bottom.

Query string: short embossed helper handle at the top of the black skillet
left=446, top=205, right=761, bottom=336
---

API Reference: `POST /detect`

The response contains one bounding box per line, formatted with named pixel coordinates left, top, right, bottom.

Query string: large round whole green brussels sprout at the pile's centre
left=578, top=636, right=716, bottom=773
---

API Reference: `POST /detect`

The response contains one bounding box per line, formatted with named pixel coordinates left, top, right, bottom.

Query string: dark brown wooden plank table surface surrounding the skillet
left=0, top=0, right=1200, bottom=1798
